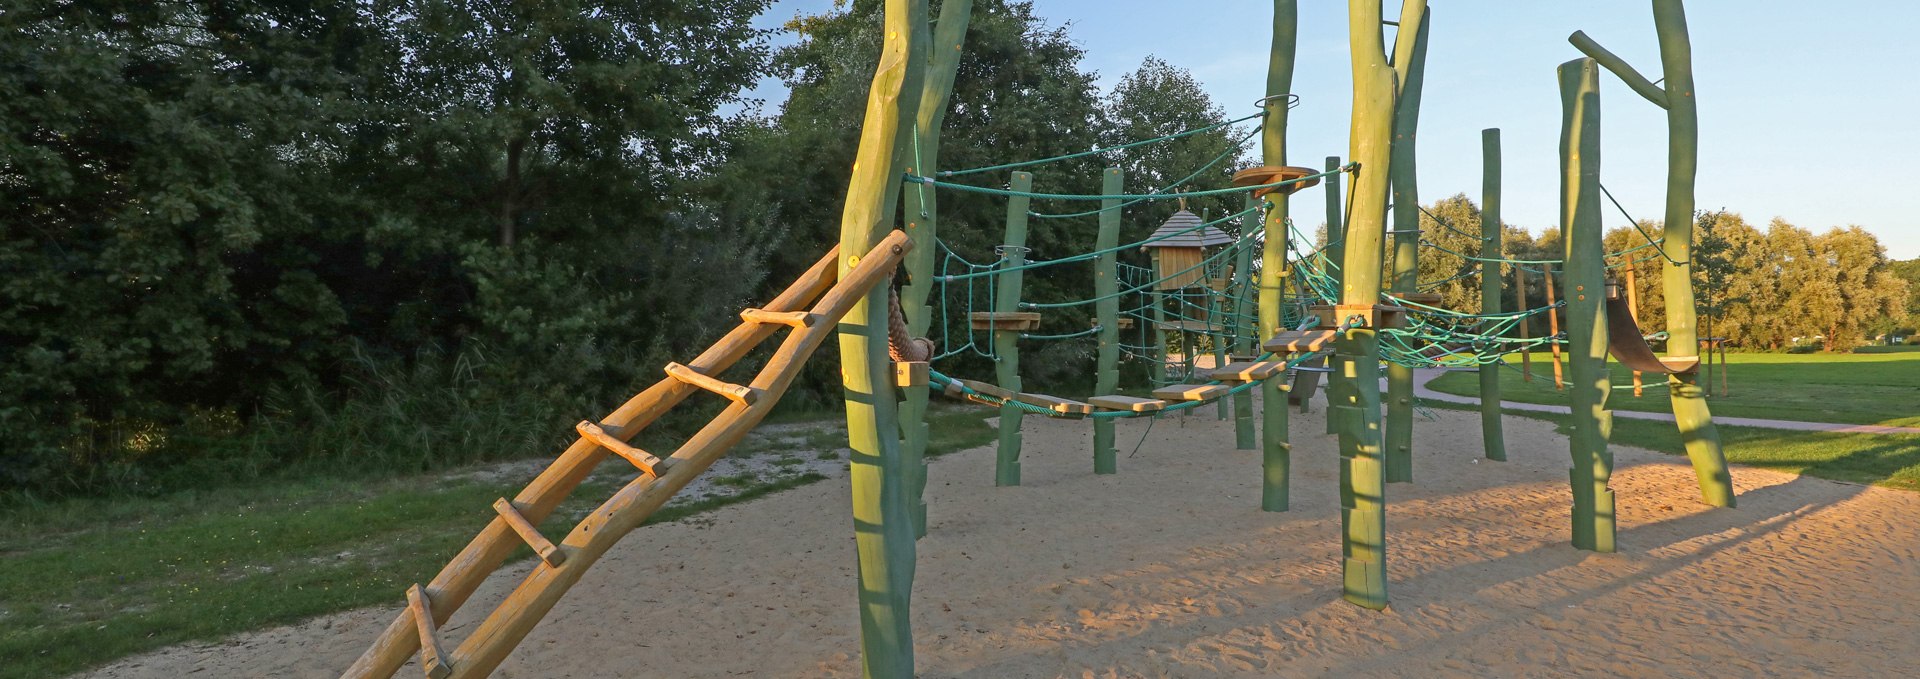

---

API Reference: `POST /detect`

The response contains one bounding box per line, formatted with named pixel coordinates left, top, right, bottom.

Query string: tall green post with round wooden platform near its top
left=1260, top=0, right=1300, bottom=512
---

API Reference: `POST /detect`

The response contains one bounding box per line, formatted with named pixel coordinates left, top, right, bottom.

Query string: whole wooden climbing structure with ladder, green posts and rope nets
left=344, top=0, right=1734, bottom=677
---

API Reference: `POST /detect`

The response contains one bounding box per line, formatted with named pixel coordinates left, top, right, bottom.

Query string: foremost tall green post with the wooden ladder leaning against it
left=839, top=0, right=927, bottom=677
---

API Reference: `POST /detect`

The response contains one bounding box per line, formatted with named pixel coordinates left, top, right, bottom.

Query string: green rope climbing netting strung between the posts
left=904, top=102, right=1665, bottom=416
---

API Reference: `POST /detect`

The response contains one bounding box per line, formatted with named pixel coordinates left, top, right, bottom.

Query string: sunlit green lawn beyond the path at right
left=1428, top=347, right=1920, bottom=426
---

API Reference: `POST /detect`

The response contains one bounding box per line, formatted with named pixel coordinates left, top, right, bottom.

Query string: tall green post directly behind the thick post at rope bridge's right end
left=1386, top=10, right=1432, bottom=483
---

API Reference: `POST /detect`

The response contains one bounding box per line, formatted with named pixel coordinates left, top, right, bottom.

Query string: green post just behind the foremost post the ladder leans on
left=900, top=0, right=973, bottom=537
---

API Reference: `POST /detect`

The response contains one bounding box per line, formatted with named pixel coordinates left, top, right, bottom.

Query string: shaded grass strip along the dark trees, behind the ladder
left=0, top=407, right=995, bottom=679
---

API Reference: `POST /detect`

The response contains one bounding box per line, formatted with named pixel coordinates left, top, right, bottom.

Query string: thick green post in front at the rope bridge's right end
left=1327, top=0, right=1421, bottom=610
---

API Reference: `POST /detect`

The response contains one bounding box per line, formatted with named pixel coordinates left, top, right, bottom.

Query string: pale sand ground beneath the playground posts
left=92, top=402, right=1920, bottom=677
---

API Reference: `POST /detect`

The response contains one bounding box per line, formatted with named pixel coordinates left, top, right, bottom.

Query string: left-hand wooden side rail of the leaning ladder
left=342, top=241, right=839, bottom=677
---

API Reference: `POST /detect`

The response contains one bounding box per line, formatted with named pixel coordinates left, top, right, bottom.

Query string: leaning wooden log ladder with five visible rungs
left=342, top=230, right=910, bottom=679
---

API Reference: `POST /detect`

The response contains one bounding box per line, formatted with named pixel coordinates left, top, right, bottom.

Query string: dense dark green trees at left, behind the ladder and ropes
left=0, top=0, right=1246, bottom=493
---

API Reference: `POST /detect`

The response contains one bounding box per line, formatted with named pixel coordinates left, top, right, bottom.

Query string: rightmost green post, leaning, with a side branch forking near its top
left=1567, top=0, right=1734, bottom=506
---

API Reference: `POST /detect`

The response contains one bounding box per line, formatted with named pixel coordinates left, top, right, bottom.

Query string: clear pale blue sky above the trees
left=760, top=0, right=1920, bottom=259
